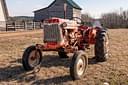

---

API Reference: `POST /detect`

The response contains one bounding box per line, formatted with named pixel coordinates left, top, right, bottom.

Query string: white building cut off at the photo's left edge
left=0, top=0, right=8, bottom=30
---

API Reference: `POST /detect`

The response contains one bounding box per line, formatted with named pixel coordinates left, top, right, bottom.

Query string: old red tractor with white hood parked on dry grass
left=22, top=18, right=108, bottom=80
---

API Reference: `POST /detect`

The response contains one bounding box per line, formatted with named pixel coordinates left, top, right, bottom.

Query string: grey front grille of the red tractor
left=44, top=24, right=62, bottom=42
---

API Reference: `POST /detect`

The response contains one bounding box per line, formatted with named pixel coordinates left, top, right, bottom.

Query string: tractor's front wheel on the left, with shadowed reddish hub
left=22, top=46, right=42, bottom=71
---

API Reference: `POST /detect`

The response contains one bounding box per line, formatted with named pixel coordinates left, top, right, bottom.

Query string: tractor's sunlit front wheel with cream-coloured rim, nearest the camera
left=70, top=51, right=88, bottom=80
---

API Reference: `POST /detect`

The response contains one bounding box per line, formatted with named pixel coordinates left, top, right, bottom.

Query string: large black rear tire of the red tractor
left=95, top=32, right=109, bottom=62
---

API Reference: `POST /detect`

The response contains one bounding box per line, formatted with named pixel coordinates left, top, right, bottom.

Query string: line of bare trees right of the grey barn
left=82, top=10, right=128, bottom=28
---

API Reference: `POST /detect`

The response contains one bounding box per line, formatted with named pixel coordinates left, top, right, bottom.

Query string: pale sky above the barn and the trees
left=6, top=0, right=128, bottom=18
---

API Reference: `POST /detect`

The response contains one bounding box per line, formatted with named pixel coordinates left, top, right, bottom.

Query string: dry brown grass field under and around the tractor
left=0, top=29, right=128, bottom=85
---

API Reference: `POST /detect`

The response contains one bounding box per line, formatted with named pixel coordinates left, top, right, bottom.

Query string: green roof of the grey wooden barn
left=34, top=0, right=82, bottom=12
